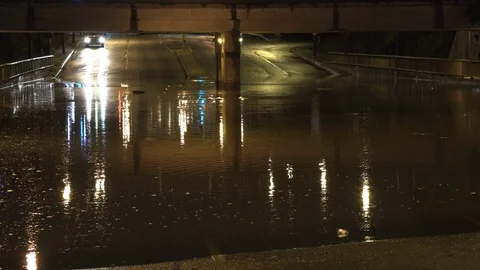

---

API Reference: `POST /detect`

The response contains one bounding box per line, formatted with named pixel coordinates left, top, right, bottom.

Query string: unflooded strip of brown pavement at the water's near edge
left=91, top=233, right=480, bottom=270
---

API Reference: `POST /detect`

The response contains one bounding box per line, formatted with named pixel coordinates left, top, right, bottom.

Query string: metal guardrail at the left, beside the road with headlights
left=0, top=55, right=53, bottom=83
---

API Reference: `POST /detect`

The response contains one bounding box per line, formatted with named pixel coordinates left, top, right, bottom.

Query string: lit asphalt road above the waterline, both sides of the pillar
left=60, top=35, right=326, bottom=89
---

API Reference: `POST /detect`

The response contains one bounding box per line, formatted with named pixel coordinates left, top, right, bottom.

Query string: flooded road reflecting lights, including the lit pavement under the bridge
left=0, top=34, right=480, bottom=269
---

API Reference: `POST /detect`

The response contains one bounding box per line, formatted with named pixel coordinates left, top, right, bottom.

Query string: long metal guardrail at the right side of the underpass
left=321, top=53, right=480, bottom=79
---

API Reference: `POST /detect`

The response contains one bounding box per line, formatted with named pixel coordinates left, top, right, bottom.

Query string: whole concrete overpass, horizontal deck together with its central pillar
left=0, top=0, right=479, bottom=87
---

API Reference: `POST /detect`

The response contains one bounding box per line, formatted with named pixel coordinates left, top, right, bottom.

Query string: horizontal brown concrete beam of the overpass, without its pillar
left=0, top=2, right=474, bottom=33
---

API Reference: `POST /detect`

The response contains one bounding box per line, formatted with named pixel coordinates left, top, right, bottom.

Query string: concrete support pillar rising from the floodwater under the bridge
left=217, top=27, right=240, bottom=90
